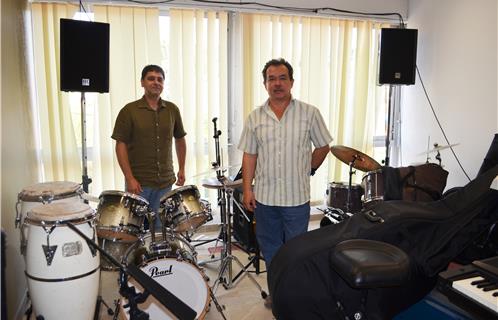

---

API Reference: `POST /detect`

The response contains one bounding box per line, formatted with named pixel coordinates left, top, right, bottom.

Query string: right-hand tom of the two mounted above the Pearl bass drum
left=160, top=185, right=212, bottom=232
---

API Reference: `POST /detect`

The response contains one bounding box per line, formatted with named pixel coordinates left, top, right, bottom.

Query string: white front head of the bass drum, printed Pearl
left=126, top=258, right=209, bottom=319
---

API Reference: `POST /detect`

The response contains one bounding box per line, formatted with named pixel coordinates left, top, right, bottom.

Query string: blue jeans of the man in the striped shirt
left=254, top=202, right=310, bottom=270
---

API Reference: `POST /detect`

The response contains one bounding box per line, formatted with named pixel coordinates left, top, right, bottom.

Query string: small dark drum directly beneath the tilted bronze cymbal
left=327, top=182, right=363, bottom=213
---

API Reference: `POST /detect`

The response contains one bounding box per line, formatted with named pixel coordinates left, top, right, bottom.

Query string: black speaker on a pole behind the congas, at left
left=60, top=19, right=109, bottom=92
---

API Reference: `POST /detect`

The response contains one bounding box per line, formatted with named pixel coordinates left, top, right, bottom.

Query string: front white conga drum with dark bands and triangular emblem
left=21, top=202, right=100, bottom=320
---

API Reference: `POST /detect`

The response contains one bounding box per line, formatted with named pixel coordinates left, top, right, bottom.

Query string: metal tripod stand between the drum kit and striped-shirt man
left=211, top=181, right=267, bottom=298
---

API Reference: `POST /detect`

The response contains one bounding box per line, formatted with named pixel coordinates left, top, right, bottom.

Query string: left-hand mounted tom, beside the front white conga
left=97, top=190, right=149, bottom=243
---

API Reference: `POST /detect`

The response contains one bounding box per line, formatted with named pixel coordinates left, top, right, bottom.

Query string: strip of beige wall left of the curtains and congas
left=0, top=0, right=37, bottom=319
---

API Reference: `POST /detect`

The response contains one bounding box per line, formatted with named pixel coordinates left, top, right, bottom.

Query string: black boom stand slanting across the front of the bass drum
left=66, top=222, right=197, bottom=320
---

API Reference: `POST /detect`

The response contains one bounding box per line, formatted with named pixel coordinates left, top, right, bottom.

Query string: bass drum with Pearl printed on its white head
left=120, top=232, right=211, bottom=320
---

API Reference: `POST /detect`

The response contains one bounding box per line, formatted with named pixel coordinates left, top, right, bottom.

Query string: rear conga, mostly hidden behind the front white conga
left=16, top=181, right=83, bottom=227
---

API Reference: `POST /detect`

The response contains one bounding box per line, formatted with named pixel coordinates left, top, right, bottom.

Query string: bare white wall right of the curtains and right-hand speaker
left=401, top=0, right=498, bottom=187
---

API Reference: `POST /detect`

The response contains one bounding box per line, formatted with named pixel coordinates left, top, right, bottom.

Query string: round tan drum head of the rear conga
left=19, top=181, right=81, bottom=202
